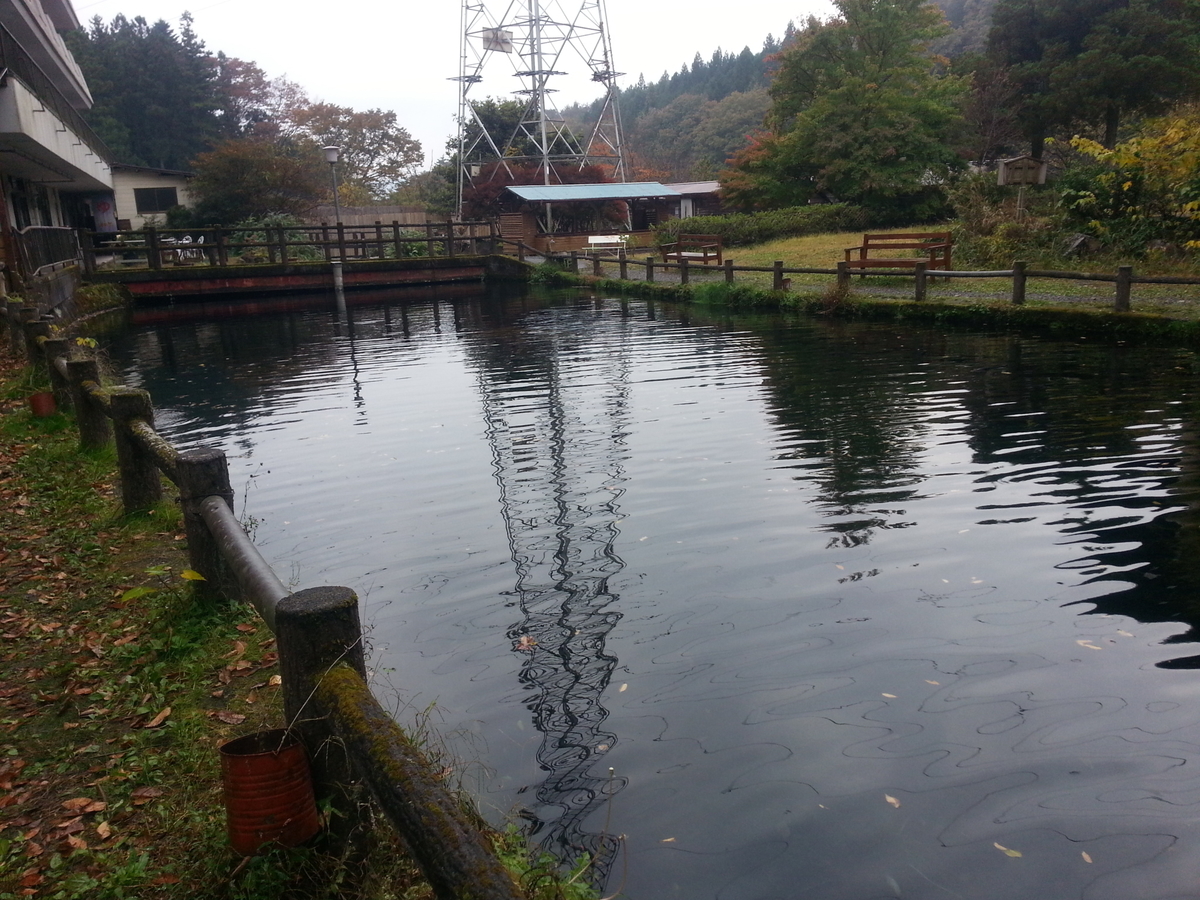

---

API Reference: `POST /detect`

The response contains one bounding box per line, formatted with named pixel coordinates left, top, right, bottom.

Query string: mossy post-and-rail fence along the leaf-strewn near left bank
left=0, top=300, right=522, bottom=900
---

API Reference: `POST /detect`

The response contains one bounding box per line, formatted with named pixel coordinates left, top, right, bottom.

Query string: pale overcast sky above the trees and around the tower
left=65, top=0, right=832, bottom=163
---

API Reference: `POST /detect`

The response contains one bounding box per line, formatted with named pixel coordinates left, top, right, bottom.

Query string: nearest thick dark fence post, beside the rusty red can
left=275, top=587, right=366, bottom=828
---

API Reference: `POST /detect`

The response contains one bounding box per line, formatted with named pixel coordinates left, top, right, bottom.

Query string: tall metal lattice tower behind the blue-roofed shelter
left=456, top=0, right=625, bottom=212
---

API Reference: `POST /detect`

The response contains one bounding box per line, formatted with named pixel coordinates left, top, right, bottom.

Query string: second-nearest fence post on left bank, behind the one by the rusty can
left=175, top=448, right=241, bottom=600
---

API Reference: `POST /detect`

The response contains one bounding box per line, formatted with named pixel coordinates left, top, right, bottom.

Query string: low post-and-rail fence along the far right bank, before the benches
left=547, top=247, right=1200, bottom=312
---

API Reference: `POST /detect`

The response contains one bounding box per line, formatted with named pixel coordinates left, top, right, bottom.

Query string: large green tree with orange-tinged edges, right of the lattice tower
left=721, top=0, right=967, bottom=218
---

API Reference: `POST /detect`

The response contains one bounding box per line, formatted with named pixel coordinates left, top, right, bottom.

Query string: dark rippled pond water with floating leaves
left=113, top=292, right=1200, bottom=900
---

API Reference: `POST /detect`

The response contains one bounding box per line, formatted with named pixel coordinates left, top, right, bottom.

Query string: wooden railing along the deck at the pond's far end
left=78, top=222, right=499, bottom=275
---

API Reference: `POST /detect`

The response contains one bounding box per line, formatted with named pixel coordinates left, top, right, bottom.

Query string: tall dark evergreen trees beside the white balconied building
left=67, top=14, right=220, bottom=169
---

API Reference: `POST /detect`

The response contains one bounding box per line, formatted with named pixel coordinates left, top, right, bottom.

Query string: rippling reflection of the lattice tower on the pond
left=476, top=309, right=629, bottom=884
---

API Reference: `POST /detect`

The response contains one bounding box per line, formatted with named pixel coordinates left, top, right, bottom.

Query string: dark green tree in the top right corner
left=988, top=0, right=1200, bottom=156
